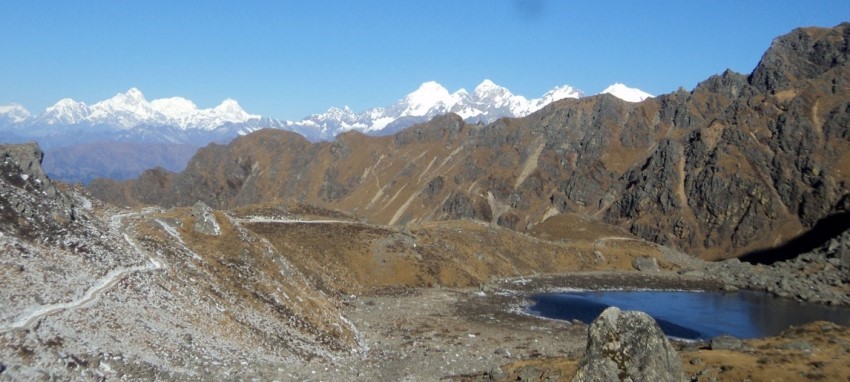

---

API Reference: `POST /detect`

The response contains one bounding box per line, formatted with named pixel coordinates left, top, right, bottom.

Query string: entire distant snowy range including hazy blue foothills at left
left=0, top=80, right=651, bottom=183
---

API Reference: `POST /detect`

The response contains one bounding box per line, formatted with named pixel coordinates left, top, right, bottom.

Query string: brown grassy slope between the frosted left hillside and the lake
left=237, top=215, right=661, bottom=294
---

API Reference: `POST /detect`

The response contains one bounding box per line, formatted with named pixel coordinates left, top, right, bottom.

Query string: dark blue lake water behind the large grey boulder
left=528, top=291, right=850, bottom=339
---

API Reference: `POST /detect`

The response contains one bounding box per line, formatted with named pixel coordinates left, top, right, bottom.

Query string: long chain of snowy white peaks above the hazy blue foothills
left=0, top=80, right=646, bottom=147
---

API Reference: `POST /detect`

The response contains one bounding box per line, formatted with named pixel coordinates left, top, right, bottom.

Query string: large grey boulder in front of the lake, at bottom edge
left=573, top=307, right=684, bottom=382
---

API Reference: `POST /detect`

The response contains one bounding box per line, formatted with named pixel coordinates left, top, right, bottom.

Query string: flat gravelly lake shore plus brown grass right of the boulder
left=274, top=272, right=850, bottom=381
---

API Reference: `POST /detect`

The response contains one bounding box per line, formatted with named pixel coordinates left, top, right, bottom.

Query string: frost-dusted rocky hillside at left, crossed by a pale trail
left=0, top=145, right=362, bottom=380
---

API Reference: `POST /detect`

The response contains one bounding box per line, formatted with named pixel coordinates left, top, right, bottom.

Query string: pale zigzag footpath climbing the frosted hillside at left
left=0, top=213, right=165, bottom=333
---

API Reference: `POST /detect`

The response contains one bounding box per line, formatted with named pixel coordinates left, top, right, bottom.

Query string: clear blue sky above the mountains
left=0, top=0, right=850, bottom=119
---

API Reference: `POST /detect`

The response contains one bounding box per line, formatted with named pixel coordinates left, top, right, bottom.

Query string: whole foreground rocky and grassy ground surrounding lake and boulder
left=0, top=139, right=850, bottom=380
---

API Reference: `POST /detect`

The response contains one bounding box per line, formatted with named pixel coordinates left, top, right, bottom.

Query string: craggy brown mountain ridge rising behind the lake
left=89, top=24, right=850, bottom=258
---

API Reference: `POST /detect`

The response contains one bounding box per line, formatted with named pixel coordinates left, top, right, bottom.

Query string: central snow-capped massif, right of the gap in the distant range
left=286, top=80, right=583, bottom=139
